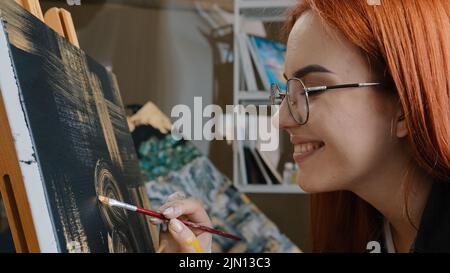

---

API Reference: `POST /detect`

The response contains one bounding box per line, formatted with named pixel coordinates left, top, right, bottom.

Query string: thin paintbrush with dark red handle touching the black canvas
left=98, top=195, right=241, bottom=241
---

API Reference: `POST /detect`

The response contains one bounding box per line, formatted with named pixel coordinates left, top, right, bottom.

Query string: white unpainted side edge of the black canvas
left=0, top=14, right=59, bottom=253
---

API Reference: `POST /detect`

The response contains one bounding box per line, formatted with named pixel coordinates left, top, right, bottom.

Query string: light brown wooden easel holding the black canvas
left=0, top=0, right=79, bottom=252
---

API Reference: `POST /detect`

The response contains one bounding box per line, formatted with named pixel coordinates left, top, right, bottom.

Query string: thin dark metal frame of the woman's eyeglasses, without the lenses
left=270, top=78, right=381, bottom=125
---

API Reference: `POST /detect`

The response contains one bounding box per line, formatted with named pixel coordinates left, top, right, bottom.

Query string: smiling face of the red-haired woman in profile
left=279, top=11, right=399, bottom=192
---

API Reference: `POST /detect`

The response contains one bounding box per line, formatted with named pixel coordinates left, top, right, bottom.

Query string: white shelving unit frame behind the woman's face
left=233, top=0, right=303, bottom=193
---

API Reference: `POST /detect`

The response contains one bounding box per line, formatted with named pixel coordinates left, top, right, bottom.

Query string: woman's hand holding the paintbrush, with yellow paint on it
left=150, top=192, right=212, bottom=253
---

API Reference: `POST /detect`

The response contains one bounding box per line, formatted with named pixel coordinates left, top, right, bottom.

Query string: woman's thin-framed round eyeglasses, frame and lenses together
left=270, top=78, right=380, bottom=125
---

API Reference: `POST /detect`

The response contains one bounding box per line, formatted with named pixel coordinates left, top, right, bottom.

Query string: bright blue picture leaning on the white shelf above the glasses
left=246, top=34, right=286, bottom=91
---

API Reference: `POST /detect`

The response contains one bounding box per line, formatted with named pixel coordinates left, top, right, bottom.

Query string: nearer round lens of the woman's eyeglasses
left=287, top=79, right=308, bottom=124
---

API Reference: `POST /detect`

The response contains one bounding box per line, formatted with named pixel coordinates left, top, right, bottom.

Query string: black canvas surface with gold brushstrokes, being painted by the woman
left=0, top=1, right=154, bottom=252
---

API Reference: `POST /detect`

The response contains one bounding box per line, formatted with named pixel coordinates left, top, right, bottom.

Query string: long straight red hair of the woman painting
left=286, top=0, right=450, bottom=252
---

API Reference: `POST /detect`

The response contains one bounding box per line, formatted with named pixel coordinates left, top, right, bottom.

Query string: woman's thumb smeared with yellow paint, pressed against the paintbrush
left=169, top=218, right=203, bottom=253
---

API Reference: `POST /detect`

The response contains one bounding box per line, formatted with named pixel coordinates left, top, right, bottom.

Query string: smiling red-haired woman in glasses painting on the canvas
left=152, top=0, right=450, bottom=252
